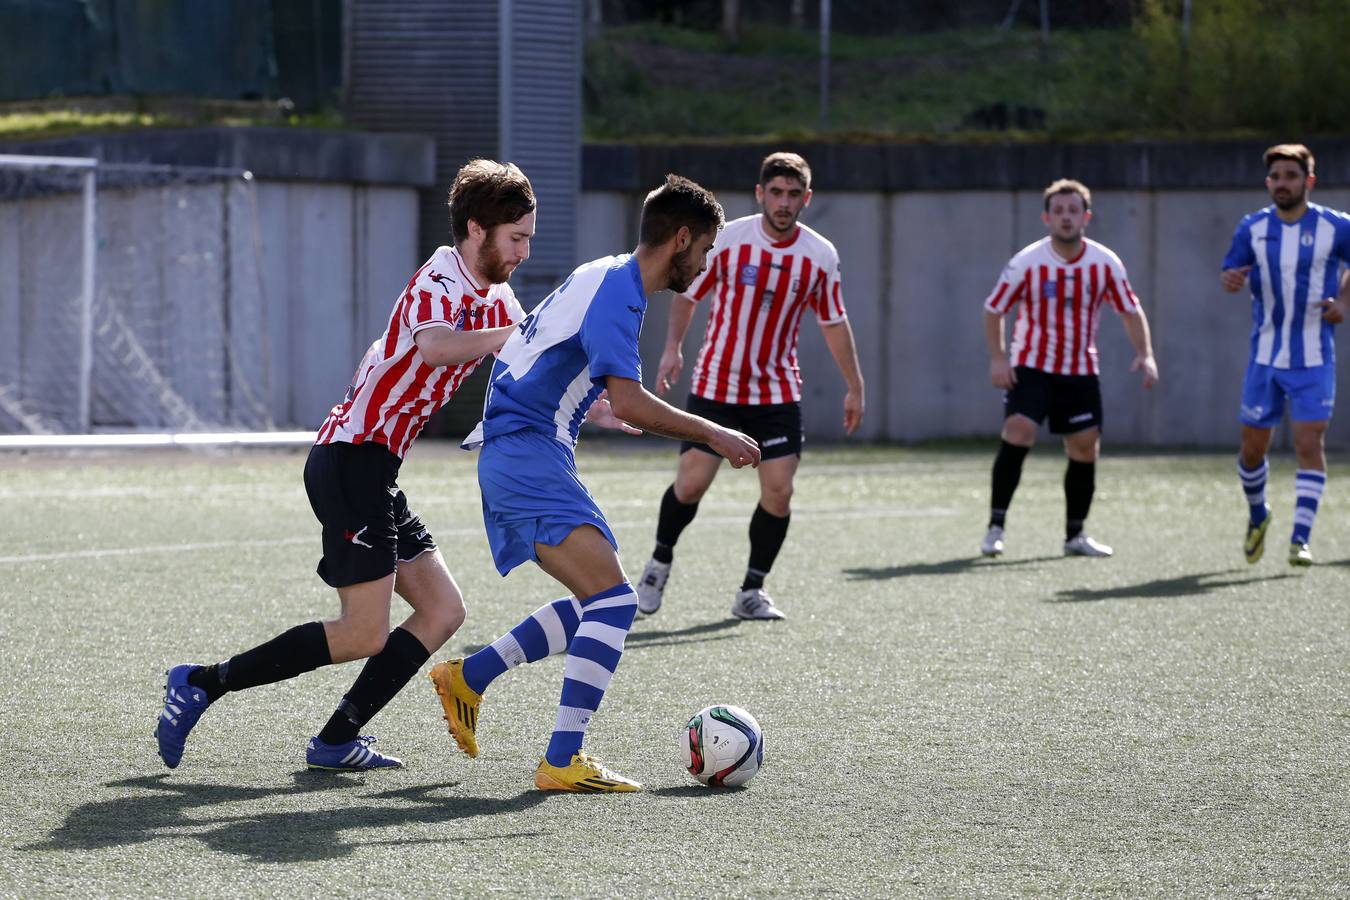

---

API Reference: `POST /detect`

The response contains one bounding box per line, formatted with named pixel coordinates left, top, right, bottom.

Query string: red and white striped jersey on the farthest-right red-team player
left=984, top=237, right=1139, bottom=375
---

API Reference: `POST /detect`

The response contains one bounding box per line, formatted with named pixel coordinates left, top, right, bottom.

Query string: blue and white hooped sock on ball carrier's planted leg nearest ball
left=544, top=582, right=637, bottom=766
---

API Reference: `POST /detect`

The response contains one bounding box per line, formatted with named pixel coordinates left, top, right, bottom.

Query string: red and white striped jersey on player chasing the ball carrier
left=315, top=247, right=525, bottom=459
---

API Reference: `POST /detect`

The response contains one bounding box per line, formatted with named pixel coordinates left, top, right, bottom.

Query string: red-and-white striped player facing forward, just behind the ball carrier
left=637, top=152, right=864, bottom=619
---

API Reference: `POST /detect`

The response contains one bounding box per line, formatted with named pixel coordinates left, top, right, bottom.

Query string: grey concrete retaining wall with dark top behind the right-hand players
left=581, top=142, right=1350, bottom=447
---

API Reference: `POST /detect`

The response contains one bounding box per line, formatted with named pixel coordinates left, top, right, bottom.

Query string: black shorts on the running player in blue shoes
left=305, top=441, right=436, bottom=587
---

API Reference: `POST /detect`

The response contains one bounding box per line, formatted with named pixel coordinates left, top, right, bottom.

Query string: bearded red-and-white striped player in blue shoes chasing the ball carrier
left=155, top=159, right=637, bottom=772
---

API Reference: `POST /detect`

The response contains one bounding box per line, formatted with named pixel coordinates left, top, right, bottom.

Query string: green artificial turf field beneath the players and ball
left=0, top=440, right=1350, bottom=897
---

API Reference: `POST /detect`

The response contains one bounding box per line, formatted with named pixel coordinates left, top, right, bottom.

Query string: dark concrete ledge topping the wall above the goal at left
left=0, top=127, right=436, bottom=188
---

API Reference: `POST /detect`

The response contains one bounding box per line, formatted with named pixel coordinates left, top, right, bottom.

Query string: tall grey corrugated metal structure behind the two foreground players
left=346, top=0, right=580, bottom=434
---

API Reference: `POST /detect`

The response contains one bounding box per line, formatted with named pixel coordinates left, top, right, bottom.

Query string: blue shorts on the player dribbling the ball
left=478, top=430, right=618, bottom=575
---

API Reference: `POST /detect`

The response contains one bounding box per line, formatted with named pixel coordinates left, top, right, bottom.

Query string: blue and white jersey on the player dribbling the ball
left=463, top=254, right=647, bottom=449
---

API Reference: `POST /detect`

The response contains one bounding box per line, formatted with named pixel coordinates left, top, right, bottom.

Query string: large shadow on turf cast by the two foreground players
left=24, top=769, right=545, bottom=862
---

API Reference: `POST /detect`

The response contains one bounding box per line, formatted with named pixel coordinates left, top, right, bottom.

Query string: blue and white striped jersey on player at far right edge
left=1223, top=204, right=1350, bottom=368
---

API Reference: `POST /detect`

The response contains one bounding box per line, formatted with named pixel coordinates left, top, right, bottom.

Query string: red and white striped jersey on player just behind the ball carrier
left=675, top=213, right=846, bottom=406
